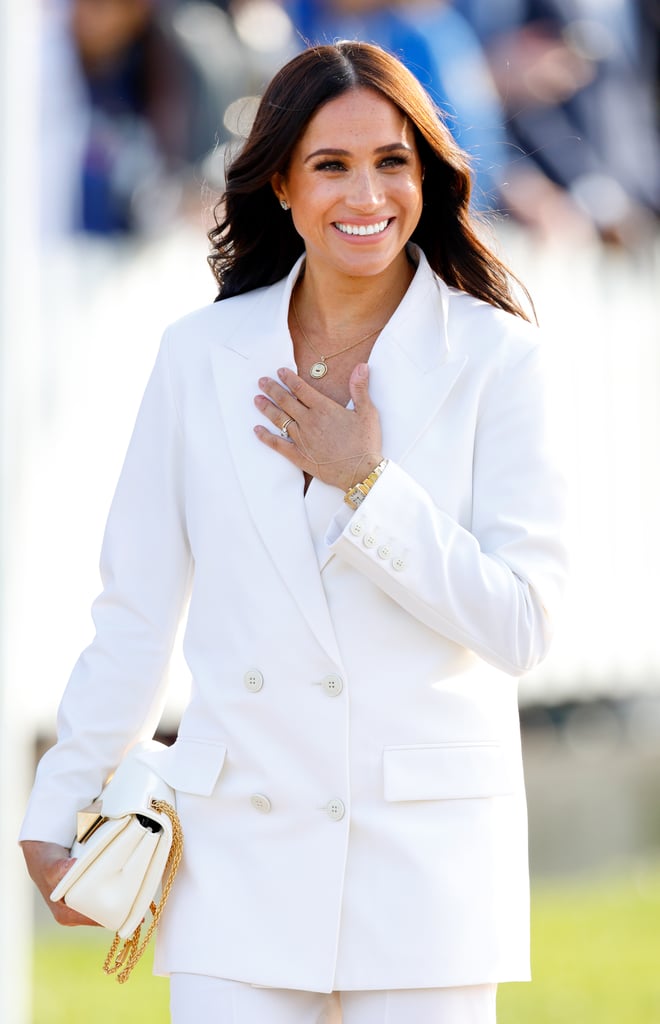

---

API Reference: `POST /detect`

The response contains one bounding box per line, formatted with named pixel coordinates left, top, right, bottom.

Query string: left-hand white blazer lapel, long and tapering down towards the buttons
left=212, top=260, right=341, bottom=664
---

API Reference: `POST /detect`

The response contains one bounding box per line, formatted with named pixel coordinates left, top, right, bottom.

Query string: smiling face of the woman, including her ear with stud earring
left=272, top=88, right=423, bottom=276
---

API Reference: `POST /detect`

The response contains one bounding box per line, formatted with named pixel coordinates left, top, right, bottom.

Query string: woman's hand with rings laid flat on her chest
left=255, top=362, right=383, bottom=490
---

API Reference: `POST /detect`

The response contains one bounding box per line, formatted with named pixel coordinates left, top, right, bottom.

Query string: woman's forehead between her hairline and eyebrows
left=298, top=88, right=414, bottom=148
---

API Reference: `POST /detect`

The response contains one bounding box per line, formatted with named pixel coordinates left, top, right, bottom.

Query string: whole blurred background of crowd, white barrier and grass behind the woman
left=0, top=0, right=660, bottom=1024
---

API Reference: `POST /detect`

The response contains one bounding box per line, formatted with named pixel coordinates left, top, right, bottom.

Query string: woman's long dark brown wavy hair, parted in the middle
left=209, top=42, right=529, bottom=319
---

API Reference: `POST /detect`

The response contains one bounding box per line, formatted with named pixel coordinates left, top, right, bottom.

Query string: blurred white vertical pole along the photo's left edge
left=0, top=0, right=40, bottom=1024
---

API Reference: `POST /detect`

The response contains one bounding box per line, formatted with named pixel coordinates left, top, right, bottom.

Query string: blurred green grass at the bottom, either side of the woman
left=33, top=865, right=660, bottom=1024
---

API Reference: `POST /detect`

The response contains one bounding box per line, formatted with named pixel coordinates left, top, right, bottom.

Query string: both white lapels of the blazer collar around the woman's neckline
left=212, top=247, right=466, bottom=651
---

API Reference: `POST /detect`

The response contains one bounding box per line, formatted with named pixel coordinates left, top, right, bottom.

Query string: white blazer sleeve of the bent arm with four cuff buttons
left=326, top=344, right=567, bottom=675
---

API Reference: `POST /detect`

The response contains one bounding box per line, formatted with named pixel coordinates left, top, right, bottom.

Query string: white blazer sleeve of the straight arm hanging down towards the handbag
left=20, top=333, right=191, bottom=846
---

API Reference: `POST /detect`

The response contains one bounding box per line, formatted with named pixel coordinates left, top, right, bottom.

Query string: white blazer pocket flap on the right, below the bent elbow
left=383, top=742, right=513, bottom=802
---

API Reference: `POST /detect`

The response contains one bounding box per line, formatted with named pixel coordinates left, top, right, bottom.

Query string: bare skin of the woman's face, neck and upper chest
left=271, top=88, right=423, bottom=404
